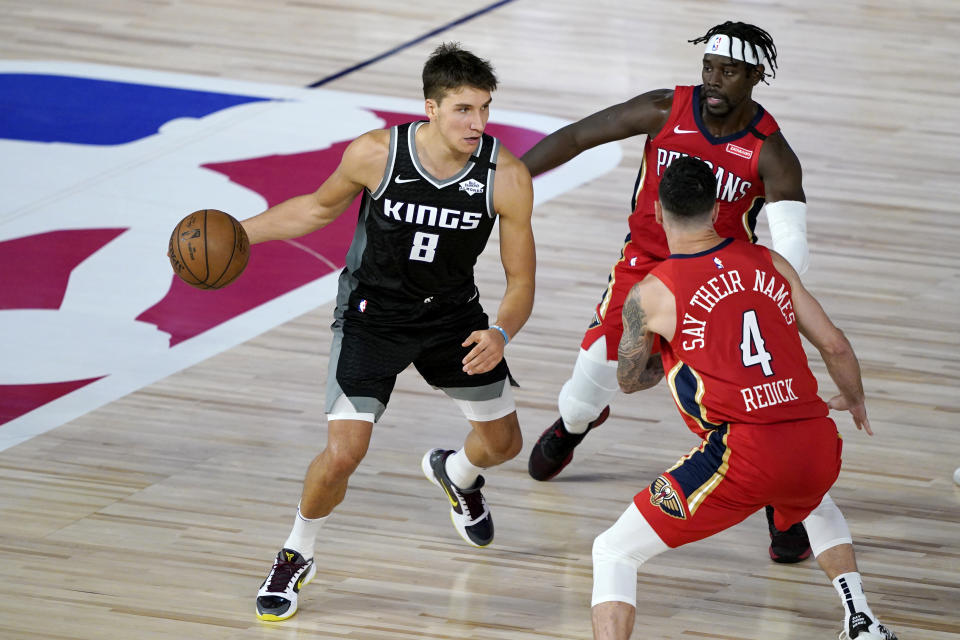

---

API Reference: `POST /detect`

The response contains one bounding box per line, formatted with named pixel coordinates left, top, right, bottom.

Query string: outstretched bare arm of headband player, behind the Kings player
left=521, top=89, right=673, bottom=176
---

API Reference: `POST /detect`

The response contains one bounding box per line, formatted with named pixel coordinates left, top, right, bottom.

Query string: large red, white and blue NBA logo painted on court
left=0, top=61, right=620, bottom=450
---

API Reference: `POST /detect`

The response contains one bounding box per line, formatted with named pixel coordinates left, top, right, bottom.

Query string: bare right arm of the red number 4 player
left=770, top=251, right=873, bottom=436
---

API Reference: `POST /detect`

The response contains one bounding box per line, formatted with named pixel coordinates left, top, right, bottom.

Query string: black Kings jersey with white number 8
left=346, top=121, right=500, bottom=302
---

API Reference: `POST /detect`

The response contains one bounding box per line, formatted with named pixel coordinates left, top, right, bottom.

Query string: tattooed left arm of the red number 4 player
left=617, top=276, right=677, bottom=393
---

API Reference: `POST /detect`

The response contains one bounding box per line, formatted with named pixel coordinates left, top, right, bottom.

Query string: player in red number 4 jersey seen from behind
left=592, top=158, right=896, bottom=640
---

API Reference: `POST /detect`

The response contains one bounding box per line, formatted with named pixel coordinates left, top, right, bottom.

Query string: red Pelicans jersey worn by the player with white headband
left=630, top=86, right=780, bottom=260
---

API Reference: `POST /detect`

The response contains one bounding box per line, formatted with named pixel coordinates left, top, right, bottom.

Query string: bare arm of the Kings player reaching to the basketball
left=242, top=130, right=390, bottom=244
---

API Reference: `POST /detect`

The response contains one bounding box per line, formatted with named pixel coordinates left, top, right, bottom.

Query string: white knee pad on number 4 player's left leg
left=590, top=504, right=669, bottom=607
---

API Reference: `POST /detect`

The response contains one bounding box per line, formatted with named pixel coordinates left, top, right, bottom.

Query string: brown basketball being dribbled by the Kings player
left=167, top=209, right=250, bottom=289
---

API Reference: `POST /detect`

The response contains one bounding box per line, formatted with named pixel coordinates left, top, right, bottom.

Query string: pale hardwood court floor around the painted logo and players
left=0, top=0, right=960, bottom=640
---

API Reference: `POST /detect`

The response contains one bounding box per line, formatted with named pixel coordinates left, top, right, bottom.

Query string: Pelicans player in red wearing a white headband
left=521, top=22, right=810, bottom=562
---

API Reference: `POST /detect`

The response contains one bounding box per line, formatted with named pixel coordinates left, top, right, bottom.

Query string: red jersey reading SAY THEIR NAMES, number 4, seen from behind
left=650, top=238, right=828, bottom=437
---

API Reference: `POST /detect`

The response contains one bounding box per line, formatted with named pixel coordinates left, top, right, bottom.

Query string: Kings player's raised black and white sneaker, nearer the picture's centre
left=420, top=449, right=493, bottom=547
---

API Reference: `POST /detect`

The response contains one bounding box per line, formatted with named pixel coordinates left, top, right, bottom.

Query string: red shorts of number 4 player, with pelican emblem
left=633, top=418, right=843, bottom=547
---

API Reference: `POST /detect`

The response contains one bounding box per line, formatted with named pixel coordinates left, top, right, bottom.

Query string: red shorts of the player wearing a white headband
left=580, top=242, right=663, bottom=362
